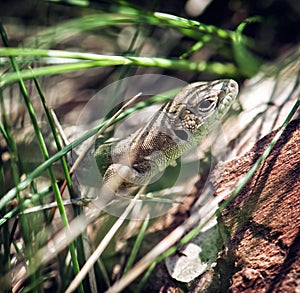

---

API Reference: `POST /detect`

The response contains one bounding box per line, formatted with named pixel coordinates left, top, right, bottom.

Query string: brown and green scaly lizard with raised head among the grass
left=93, top=79, right=238, bottom=191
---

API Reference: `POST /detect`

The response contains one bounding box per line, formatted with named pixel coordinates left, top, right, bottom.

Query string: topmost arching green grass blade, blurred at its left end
left=20, top=10, right=257, bottom=49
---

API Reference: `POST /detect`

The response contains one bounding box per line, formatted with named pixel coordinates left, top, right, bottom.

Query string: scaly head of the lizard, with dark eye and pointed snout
left=165, top=79, right=238, bottom=139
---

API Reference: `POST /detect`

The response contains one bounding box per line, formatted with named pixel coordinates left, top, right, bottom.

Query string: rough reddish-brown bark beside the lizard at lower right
left=211, top=120, right=300, bottom=292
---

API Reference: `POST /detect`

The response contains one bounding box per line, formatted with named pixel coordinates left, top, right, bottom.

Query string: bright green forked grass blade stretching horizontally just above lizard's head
left=0, top=48, right=238, bottom=87
